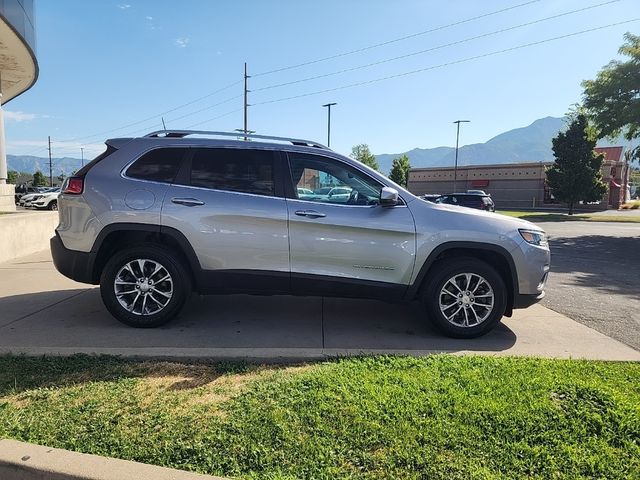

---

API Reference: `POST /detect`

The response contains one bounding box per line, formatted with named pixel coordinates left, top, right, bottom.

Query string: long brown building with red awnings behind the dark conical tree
left=408, top=147, right=628, bottom=209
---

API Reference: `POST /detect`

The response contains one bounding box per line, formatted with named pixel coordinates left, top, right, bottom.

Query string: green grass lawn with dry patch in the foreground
left=0, top=355, right=640, bottom=480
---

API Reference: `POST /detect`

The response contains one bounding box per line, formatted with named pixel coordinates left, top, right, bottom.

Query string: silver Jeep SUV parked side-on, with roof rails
left=51, top=131, right=550, bottom=338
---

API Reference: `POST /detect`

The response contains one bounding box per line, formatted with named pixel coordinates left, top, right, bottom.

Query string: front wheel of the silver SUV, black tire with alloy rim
left=423, top=257, right=507, bottom=338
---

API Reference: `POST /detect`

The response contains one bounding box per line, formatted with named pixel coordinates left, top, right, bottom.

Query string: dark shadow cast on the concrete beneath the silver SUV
left=0, top=288, right=516, bottom=354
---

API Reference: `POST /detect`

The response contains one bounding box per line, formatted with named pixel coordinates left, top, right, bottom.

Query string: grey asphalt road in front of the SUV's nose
left=539, top=222, right=640, bottom=350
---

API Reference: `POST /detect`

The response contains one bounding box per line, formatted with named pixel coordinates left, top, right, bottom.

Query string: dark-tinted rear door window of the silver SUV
left=190, top=148, right=275, bottom=196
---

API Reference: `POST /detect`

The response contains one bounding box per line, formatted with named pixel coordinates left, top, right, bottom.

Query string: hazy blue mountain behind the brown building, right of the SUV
left=376, top=117, right=629, bottom=173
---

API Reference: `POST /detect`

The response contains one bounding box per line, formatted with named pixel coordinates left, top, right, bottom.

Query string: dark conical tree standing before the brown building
left=547, top=114, right=607, bottom=215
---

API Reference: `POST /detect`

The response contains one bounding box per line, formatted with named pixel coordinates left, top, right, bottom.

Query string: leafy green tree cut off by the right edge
left=582, top=33, right=640, bottom=160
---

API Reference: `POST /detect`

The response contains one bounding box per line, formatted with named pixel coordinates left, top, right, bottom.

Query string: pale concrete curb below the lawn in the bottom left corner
left=0, top=440, right=225, bottom=480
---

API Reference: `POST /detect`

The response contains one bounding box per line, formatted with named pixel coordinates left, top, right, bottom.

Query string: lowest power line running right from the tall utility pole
left=253, top=17, right=640, bottom=106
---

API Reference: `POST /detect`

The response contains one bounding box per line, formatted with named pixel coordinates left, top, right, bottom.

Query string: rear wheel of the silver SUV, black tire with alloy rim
left=100, top=244, right=191, bottom=328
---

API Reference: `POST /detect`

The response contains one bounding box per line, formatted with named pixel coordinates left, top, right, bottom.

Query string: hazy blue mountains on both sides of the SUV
left=7, top=117, right=629, bottom=176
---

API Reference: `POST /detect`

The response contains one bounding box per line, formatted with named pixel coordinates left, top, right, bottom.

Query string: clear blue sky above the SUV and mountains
left=4, top=0, right=640, bottom=158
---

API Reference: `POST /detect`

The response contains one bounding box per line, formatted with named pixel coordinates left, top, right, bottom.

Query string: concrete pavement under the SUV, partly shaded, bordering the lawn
left=0, top=251, right=640, bottom=362
